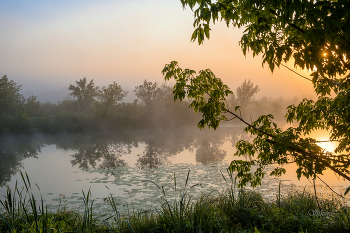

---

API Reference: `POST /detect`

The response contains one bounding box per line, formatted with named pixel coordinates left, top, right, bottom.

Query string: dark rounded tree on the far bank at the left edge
left=0, top=75, right=24, bottom=116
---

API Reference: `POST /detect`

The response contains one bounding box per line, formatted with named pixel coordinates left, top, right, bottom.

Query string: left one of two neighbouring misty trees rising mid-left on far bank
left=68, top=78, right=98, bottom=113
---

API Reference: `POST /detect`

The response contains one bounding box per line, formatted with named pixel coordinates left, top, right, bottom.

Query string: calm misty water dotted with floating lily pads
left=0, top=126, right=349, bottom=214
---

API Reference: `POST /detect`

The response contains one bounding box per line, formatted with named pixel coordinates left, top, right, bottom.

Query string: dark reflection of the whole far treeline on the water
left=0, top=127, right=245, bottom=186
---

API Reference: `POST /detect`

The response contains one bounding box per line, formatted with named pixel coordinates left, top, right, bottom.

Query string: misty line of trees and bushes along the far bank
left=0, top=75, right=300, bottom=134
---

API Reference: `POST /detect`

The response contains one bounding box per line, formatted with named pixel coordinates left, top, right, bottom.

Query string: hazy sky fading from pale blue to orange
left=0, top=0, right=313, bottom=102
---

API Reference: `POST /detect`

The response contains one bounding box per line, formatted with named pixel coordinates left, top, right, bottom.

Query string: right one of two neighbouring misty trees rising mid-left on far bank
left=98, top=82, right=128, bottom=116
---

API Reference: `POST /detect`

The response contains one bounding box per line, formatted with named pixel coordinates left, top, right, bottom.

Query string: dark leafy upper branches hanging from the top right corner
left=185, top=0, right=350, bottom=78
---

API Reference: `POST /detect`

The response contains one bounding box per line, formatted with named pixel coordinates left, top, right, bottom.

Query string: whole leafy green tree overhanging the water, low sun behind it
left=162, top=0, right=350, bottom=195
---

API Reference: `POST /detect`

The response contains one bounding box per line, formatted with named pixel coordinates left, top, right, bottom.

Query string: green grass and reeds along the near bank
left=0, top=171, right=350, bottom=233
